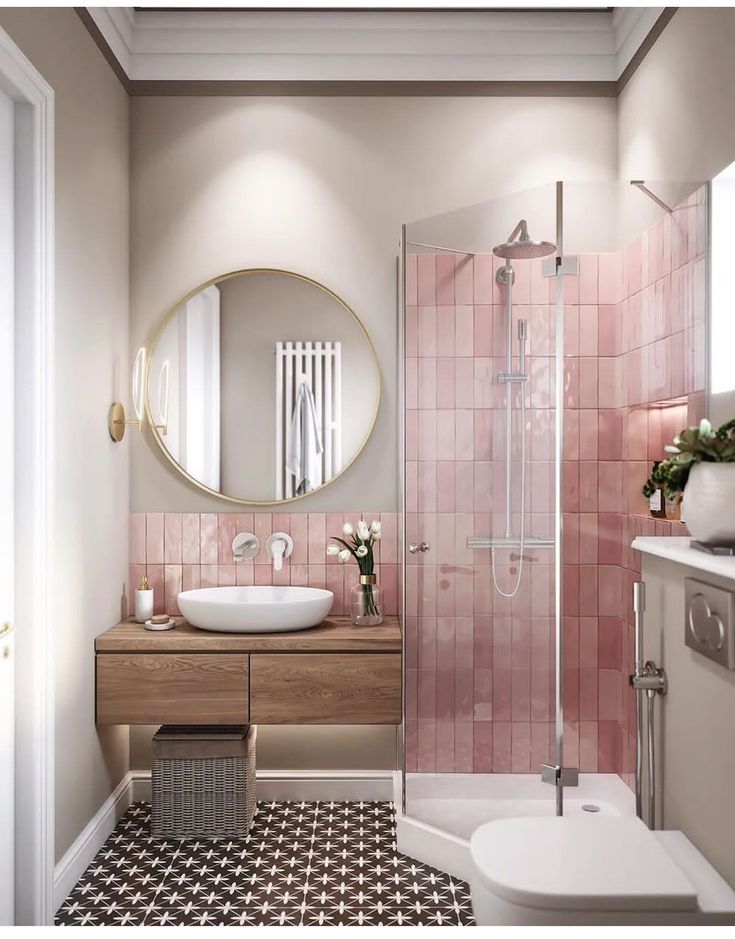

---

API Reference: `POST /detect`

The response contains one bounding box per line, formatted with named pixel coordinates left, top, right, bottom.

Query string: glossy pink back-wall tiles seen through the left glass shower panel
left=406, top=246, right=554, bottom=772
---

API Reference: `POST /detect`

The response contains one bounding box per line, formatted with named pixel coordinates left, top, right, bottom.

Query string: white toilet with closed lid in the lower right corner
left=470, top=816, right=735, bottom=926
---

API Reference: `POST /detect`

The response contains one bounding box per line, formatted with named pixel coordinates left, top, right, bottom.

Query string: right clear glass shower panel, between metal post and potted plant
left=563, top=181, right=708, bottom=788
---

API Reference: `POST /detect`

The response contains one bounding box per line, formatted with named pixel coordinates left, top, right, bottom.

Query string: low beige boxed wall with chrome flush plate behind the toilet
left=643, top=557, right=735, bottom=886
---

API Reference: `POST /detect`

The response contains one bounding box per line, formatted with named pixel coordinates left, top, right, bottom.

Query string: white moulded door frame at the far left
left=0, top=29, right=55, bottom=926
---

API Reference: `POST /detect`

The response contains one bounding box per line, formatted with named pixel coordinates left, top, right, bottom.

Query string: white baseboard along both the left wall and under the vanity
left=54, top=769, right=397, bottom=909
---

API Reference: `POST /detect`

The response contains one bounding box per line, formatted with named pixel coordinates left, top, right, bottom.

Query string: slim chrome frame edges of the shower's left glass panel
left=397, top=181, right=564, bottom=815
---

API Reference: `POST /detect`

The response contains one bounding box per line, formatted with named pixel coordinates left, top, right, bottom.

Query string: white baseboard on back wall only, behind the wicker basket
left=130, top=769, right=396, bottom=802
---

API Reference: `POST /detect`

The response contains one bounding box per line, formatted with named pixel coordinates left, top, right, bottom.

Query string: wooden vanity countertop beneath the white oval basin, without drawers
left=94, top=616, right=402, bottom=652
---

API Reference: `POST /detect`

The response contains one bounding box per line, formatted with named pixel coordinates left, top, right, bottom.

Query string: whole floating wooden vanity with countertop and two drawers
left=95, top=616, right=402, bottom=724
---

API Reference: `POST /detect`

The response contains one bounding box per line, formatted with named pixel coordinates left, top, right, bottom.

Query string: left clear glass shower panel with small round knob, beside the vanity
left=403, top=185, right=560, bottom=835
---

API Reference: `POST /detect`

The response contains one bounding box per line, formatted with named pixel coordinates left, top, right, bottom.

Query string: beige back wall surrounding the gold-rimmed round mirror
left=131, top=97, right=617, bottom=512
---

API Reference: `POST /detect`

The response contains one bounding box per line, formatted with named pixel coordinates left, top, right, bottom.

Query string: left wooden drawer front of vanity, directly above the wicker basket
left=97, top=653, right=249, bottom=724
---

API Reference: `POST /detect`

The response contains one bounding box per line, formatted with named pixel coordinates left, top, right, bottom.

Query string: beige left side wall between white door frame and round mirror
left=0, top=8, right=129, bottom=858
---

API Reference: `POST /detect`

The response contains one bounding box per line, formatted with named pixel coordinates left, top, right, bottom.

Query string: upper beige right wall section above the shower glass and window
left=618, top=7, right=735, bottom=180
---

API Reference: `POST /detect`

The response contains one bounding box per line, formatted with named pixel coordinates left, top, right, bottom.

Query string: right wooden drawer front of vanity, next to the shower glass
left=250, top=652, right=401, bottom=724
